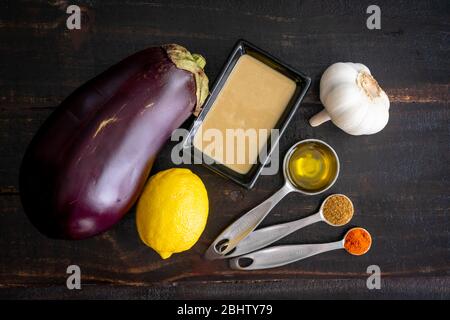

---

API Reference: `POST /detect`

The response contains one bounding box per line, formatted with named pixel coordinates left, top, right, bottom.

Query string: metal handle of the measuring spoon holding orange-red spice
left=230, top=240, right=343, bottom=270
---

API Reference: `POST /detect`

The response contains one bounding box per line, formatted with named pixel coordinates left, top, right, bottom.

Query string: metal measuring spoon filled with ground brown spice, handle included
left=225, top=194, right=354, bottom=258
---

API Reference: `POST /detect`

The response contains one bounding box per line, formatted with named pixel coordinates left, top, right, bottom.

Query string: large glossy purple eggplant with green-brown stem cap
left=19, top=44, right=208, bottom=239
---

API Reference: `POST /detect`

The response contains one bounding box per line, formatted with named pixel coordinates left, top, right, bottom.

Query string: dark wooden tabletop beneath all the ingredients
left=0, top=0, right=450, bottom=299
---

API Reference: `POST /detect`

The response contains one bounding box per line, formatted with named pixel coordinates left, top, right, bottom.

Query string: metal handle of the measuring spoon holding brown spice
left=227, top=212, right=322, bottom=258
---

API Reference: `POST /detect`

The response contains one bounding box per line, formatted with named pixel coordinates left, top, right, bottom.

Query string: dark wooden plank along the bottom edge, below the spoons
left=0, top=277, right=450, bottom=300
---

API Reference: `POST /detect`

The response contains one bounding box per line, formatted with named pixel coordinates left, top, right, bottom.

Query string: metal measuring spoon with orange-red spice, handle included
left=230, top=227, right=372, bottom=270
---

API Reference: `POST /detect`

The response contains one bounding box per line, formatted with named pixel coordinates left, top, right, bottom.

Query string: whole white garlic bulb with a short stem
left=309, top=62, right=389, bottom=135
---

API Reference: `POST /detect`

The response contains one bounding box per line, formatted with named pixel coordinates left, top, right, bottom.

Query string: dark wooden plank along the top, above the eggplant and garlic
left=0, top=1, right=450, bottom=108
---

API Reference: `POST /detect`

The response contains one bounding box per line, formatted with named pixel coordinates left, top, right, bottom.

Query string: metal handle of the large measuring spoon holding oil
left=205, top=183, right=294, bottom=259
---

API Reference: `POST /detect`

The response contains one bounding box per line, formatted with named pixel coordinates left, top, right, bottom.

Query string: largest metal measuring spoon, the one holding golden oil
left=205, top=139, right=339, bottom=259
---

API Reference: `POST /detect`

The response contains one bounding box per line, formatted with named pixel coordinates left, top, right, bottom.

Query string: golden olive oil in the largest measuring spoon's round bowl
left=288, top=141, right=338, bottom=192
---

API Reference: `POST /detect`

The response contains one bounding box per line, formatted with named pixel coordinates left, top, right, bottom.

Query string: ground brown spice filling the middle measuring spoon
left=323, top=195, right=353, bottom=226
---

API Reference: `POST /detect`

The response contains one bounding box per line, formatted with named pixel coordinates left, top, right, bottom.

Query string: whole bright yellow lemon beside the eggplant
left=136, top=168, right=208, bottom=259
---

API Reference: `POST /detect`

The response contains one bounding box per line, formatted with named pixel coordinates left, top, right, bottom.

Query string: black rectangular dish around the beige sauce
left=183, top=40, right=311, bottom=189
